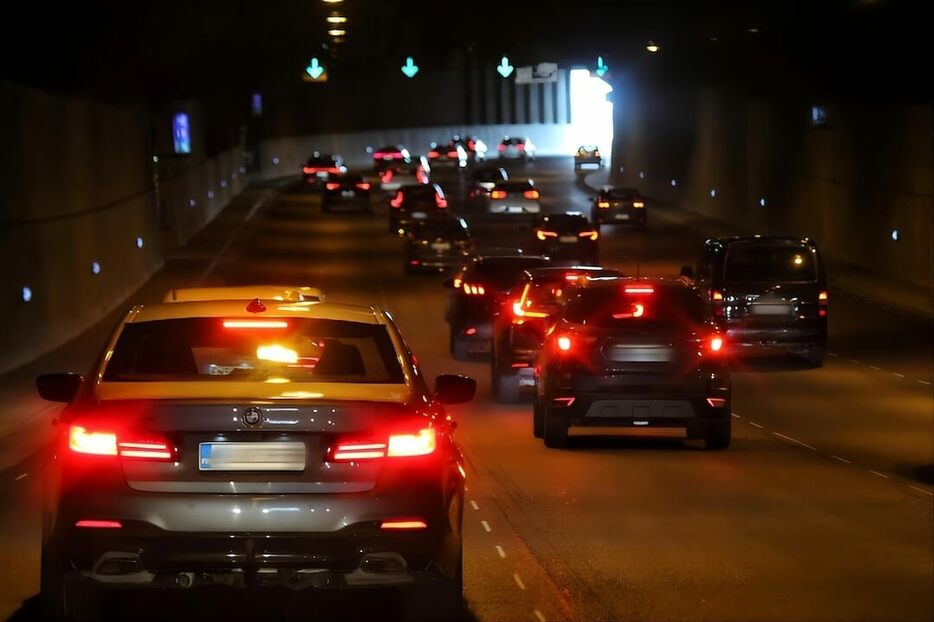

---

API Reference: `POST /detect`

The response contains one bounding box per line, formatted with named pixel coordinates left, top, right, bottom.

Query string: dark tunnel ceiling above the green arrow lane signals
left=0, top=0, right=934, bottom=100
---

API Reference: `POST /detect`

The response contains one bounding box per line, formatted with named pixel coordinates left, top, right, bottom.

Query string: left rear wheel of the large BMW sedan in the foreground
left=39, top=550, right=101, bottom=622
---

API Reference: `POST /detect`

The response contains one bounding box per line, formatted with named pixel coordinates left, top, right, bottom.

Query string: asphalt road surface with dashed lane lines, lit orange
left=0, top=159, right=934, bottom=621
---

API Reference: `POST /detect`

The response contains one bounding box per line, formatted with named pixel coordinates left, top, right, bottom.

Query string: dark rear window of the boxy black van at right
left=723, top=240, right=817, bottom=283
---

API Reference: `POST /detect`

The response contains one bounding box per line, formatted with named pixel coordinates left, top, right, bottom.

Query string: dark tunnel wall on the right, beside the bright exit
left=612, top=82, right=934, bottom=287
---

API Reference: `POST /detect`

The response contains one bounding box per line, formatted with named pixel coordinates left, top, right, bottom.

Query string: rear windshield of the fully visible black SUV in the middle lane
left=565, top=285, right=707, bottom=328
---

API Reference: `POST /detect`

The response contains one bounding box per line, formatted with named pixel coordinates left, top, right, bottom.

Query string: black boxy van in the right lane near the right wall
left=682, top=236, right=829, bottom=367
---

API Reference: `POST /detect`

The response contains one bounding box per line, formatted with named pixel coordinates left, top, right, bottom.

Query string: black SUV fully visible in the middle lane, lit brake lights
left=532, top=278, right=732, bottom=449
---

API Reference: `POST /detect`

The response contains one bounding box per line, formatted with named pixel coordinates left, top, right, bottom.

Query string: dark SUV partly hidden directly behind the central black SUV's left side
left=491, top=266, right=622, bottom=403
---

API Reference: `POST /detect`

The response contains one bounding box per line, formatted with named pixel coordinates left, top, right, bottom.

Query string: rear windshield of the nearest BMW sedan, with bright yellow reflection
left=104, top=317, right=404, bottom=383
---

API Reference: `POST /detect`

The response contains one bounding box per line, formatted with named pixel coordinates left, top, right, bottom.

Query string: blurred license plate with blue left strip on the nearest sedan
left=198, top=442, right=305, bottom=471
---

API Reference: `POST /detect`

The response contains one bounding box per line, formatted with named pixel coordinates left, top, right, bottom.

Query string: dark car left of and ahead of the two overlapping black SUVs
left=444, top=253, right=548, bottom=360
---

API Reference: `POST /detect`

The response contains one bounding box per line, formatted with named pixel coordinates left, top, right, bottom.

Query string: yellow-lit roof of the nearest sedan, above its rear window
left=125, top=299, right=383, bottom=324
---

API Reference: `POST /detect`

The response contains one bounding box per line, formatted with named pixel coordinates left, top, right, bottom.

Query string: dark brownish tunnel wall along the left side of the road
left=0, top=83, right=242, bottom=372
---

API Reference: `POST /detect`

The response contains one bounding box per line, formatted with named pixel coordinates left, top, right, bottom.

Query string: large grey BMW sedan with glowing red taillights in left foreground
left=37, top=299, right=476, bottom=620
